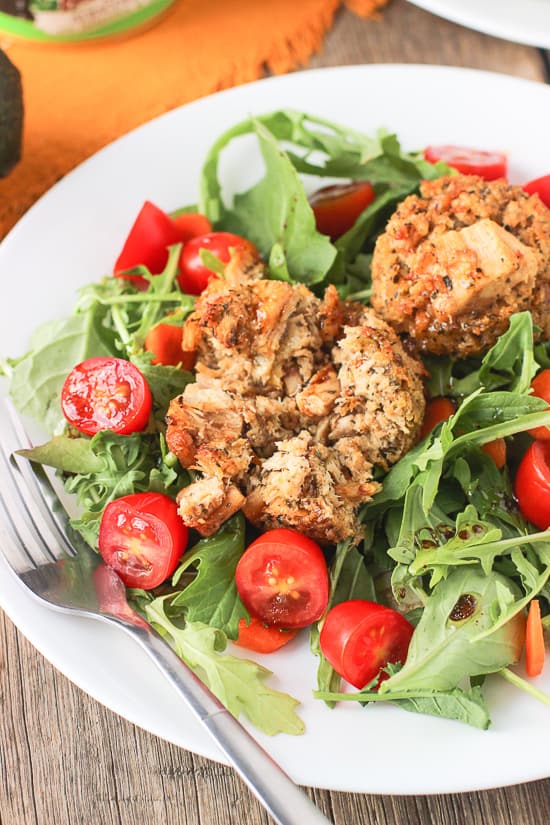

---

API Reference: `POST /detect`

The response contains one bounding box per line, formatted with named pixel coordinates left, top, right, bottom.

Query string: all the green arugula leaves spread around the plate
left=3, top=110, right=550, bottom=734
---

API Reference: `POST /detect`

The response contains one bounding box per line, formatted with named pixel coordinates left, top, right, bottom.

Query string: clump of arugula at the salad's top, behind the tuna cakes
left=200, top=110, right=453, bottom=297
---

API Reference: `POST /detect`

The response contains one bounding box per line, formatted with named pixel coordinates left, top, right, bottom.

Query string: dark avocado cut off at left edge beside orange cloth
left=0, top=50, right=23, bottom=177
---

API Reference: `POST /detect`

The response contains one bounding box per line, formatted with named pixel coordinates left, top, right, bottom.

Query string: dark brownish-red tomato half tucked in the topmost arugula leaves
left=309, top=180, right=376, bottom=241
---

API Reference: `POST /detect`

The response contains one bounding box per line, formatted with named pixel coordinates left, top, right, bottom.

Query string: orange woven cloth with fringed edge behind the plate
left=0, top=0, right=387, bottom=238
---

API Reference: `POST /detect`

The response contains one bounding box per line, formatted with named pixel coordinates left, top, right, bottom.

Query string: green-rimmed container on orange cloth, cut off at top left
left=0, top=0, right=174, bottom=43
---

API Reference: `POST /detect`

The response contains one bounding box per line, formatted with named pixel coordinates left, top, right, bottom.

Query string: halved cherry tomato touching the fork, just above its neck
left=98, top=493, right=188, bottom=590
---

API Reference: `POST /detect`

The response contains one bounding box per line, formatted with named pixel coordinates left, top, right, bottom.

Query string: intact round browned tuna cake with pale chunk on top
left=372, top=175, right=550, bottom=357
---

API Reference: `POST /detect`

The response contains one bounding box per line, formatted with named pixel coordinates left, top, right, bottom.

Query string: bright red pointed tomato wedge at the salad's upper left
left=113, top=201, right=187, bottom=289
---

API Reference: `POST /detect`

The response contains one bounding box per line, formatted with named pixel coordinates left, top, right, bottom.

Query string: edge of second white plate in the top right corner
left=410, top=0, right=550, bottom=49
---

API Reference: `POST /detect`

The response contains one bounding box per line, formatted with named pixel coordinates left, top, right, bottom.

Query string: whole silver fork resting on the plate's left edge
left=0, top=402, right=330, bottom=825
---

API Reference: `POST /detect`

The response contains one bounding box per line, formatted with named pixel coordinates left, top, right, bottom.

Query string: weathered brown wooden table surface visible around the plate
left=0, top=0, right=550, bottom=825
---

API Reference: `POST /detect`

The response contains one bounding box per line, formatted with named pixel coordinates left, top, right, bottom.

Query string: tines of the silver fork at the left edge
left=0, top=398, right=74, bottom=568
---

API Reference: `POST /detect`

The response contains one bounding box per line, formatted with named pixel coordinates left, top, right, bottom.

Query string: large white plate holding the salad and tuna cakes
left=0, top=65, right=550, bottom=794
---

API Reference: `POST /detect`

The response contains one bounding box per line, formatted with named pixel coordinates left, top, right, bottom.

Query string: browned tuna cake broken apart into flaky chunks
left=167, top=253, right=424, bottom=543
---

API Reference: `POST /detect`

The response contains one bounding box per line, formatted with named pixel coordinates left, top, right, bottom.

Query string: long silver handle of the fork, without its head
left=121, top=622, right=332, bottom=825
